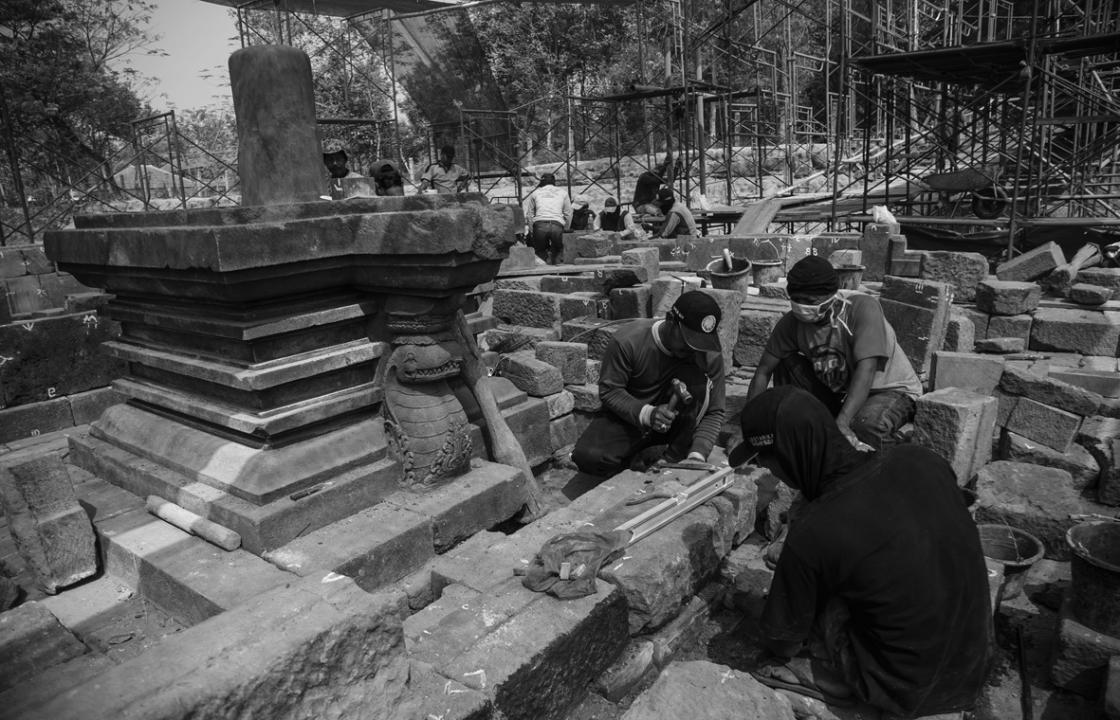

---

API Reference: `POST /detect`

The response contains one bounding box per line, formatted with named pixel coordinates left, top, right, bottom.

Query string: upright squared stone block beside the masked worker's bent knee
left=913, top=387, right=998, bottom=486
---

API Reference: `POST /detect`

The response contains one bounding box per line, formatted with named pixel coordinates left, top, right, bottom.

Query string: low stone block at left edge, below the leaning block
left=0, top=601, right=90, bottom=691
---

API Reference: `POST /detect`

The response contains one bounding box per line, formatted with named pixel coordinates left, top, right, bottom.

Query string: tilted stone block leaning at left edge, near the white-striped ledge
left=0, top=455, right=97, bottom=595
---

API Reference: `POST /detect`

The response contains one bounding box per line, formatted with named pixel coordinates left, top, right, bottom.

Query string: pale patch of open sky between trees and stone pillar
left=122, top=0, right=241, bottom=111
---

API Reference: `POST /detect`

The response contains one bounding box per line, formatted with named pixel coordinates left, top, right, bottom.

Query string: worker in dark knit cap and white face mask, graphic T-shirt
left=747, top=255, right=922, bottom=450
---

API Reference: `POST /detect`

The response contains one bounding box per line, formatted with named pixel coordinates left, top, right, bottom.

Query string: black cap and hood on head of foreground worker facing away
left=731, top=385, right=870, bottom=501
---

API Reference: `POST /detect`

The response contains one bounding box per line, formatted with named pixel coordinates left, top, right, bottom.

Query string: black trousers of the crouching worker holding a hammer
left=571, top=365, right=708, bottom=477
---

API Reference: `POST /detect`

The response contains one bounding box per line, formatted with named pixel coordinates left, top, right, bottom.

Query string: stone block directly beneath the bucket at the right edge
left=1049, top=590, right=1120, bottom=699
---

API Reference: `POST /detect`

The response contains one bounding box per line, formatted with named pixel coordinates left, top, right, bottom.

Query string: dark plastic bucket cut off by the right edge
left=1065, top=521, right=1120, bottom=637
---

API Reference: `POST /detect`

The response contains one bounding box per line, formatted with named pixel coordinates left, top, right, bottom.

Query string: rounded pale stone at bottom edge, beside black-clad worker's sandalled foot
left=622, top=661, right=796, bottom=720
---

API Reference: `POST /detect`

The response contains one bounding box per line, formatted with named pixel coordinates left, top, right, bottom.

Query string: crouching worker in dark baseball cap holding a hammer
left=571, top=291, right=725, bottom=477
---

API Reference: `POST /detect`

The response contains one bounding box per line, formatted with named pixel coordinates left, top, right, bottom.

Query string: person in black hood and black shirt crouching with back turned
left=728, top=385, right=992, bottom=718
